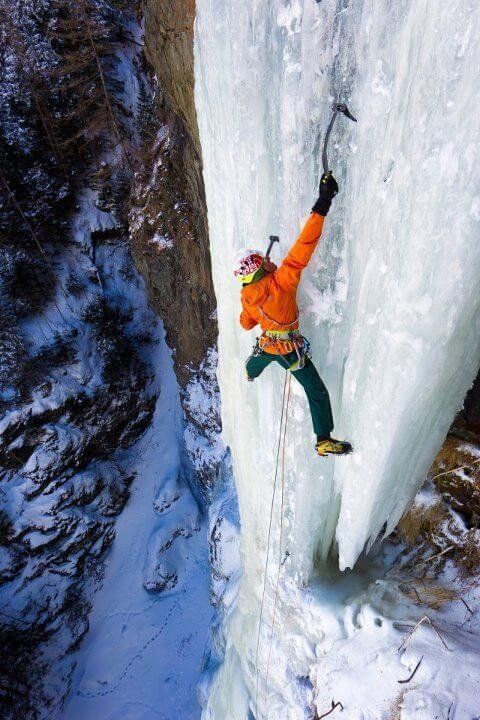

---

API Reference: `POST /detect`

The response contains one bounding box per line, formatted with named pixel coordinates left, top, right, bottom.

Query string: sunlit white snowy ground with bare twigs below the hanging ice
left=249, top=549, right=480, bottom=720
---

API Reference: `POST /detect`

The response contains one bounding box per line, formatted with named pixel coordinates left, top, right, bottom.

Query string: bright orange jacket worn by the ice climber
left=240, top=212, right=325, bottom=353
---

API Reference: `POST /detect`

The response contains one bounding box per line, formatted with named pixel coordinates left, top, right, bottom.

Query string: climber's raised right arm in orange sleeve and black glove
left=275, top=173, right=338, bottom=290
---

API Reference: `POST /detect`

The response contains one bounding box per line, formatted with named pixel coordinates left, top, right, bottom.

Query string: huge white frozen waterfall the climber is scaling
left=196, top=0, right=480, bottom=720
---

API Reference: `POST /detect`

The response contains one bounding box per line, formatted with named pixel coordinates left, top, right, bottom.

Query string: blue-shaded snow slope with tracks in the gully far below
left=62, top=310, right=213, bottom=720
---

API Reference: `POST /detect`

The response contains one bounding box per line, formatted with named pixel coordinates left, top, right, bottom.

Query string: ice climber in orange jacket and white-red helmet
left=235, top=172, right=352, bottom=457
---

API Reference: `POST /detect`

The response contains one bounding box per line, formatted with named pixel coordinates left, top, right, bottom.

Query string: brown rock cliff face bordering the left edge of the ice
left=131, top=0, right=217, bottom=387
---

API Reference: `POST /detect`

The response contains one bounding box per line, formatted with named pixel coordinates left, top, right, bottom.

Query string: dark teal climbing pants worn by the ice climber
left=246, top=350, right=333, bottom=437
